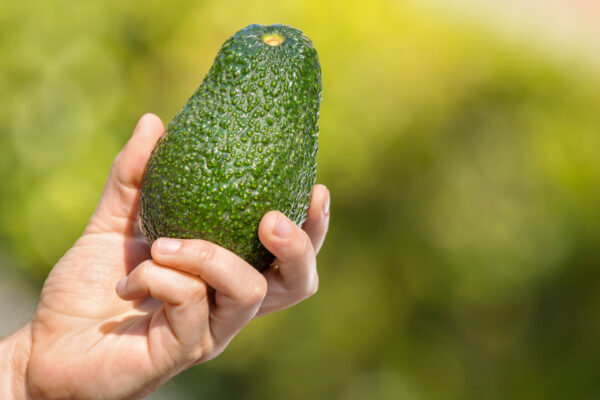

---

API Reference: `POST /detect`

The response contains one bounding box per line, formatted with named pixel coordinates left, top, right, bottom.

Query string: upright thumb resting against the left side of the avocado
left=86, top=114, right=165, bottom=234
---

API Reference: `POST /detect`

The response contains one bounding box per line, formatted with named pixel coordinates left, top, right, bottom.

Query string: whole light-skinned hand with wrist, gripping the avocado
left=0, top=114, right=329, bottom=399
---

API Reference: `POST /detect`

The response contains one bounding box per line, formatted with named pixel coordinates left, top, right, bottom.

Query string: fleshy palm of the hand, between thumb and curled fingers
left=30, top=205, right=193, bottom=398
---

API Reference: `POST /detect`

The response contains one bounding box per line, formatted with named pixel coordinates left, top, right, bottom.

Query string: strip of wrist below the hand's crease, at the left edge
left=0, top=324, right=31, bottom=400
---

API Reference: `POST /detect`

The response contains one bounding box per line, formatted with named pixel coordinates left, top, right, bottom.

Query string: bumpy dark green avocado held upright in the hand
left=139, top=25, right=322, bottom=270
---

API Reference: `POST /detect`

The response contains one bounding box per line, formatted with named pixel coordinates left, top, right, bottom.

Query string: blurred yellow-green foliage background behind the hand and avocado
left=0, top=0, right=600, bottom=400
